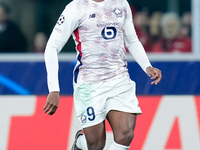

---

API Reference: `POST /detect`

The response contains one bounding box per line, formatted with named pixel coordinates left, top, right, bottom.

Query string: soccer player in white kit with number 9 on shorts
left=44, top=0, right=162, bottom=150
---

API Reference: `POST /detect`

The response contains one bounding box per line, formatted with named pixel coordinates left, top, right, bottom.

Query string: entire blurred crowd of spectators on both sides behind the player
left=0, top=2, right=191, bottom=53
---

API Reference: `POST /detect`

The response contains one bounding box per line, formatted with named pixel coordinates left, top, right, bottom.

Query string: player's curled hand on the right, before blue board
left=146, top=67, right=162, bottom=85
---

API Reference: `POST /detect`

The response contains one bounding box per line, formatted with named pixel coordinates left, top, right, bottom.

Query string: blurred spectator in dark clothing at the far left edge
left=0, top=2, right=27, bottom=53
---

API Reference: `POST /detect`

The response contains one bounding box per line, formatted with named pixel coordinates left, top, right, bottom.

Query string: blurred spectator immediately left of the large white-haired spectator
left=149, top=12, right=162, bottom=46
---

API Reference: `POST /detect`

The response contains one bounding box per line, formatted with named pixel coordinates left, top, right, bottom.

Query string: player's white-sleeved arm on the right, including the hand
left=124, top=0, right=162, bottom=85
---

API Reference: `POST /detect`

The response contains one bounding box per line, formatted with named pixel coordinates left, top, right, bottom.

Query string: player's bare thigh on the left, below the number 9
left=83, top=121, right=106, bottom=145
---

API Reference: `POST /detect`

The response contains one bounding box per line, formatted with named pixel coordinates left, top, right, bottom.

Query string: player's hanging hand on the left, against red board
left=43, top=91, right=59, bottom=115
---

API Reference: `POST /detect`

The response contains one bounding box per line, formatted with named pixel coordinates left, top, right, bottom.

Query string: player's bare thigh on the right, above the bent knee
left=107, top=110, right=137, bottom=138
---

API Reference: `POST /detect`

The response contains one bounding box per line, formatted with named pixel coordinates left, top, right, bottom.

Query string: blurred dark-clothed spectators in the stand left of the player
left=0, top=2, right=48, bottom=53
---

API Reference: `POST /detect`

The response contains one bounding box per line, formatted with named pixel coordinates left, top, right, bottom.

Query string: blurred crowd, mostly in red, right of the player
left=133, top=6, right=191, bottom=53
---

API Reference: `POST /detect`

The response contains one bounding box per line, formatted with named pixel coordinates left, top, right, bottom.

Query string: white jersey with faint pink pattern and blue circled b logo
left=51, top=0, right=132, bottom=83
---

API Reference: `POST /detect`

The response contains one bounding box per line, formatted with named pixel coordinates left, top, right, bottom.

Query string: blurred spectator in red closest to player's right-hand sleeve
left=133, top=11, right=150, bottom=52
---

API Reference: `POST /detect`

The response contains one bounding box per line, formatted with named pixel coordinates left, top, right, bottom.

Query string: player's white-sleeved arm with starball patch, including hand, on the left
left=43, top=1, right=78, bottom=115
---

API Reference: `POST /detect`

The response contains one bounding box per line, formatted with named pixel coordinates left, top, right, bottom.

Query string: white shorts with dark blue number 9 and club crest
left=74, top=76, right=142, bottom=128
